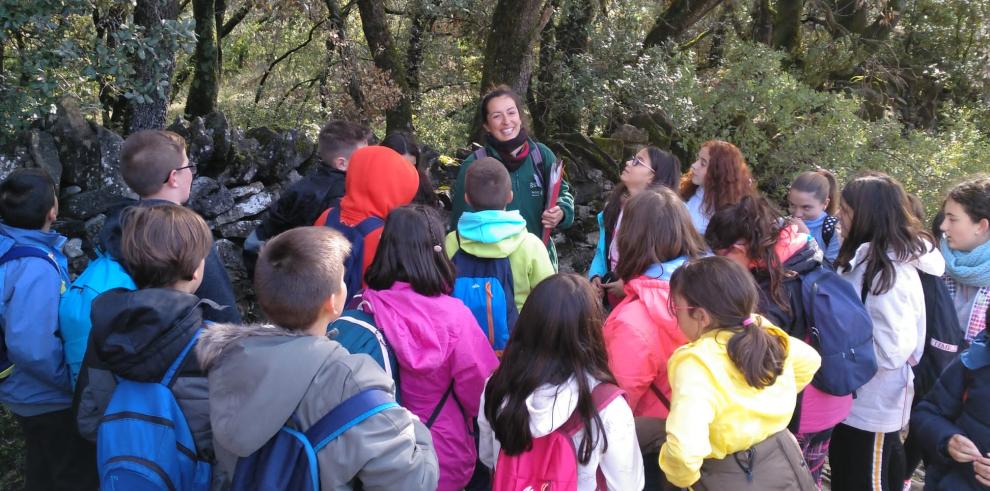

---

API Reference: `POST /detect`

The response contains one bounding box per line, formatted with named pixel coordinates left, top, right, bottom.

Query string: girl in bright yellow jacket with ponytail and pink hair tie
left=660, top=256, right=821, bottom=491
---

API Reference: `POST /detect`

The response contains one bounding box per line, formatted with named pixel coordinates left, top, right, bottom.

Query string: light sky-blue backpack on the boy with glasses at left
left=58, top=253, right=137, bottom=387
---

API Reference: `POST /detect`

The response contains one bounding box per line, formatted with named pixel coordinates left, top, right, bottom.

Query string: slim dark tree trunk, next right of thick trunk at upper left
left=185, top=0, right=220, bottom=118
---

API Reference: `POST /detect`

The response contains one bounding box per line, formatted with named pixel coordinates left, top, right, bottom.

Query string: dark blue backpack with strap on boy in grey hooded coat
left=231, top=389, right=398, bottom=491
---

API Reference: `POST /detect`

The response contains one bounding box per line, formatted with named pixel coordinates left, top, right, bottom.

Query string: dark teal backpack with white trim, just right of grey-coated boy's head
left=327, top=303, right=401, bottom=404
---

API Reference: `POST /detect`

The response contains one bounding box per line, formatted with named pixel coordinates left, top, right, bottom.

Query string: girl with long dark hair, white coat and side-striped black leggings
left=829, top=173, right=945, bottom=490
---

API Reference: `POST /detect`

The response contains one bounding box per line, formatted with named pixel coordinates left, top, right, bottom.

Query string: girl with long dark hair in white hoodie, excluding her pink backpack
left=478, top=274, right=643, bottom=491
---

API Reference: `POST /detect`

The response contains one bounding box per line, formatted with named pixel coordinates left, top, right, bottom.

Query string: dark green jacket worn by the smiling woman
left=450, top=138, right=574, bottom=270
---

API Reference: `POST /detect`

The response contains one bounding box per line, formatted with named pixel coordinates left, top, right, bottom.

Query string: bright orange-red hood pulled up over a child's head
left=340, top=146, right=419, bottom=226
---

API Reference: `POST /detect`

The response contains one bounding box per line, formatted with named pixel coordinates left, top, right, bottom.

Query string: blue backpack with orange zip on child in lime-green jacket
left=452, top=232, right=519, bottom=356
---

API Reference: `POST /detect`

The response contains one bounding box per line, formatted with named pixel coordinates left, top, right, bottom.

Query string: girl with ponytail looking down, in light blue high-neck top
left=787, top=169, right=842, bottom=264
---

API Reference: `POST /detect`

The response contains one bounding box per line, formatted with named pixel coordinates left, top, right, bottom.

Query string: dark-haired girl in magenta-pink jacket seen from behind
left=363, top=205, right=498, bottom=491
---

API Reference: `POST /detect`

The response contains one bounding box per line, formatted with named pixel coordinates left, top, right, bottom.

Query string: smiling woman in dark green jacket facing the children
left=450, top=85, right=574, bottom=269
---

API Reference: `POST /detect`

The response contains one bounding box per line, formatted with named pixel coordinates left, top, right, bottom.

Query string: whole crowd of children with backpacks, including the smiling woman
left=0, top=83, right=990, bottom=490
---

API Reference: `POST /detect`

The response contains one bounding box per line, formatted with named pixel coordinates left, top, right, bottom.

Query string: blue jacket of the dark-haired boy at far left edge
left=0, top=223, right=72, bottom=416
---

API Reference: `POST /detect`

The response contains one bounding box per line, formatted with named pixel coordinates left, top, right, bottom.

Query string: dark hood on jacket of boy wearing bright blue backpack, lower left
left=90, top=288, right=203, bottom=382
